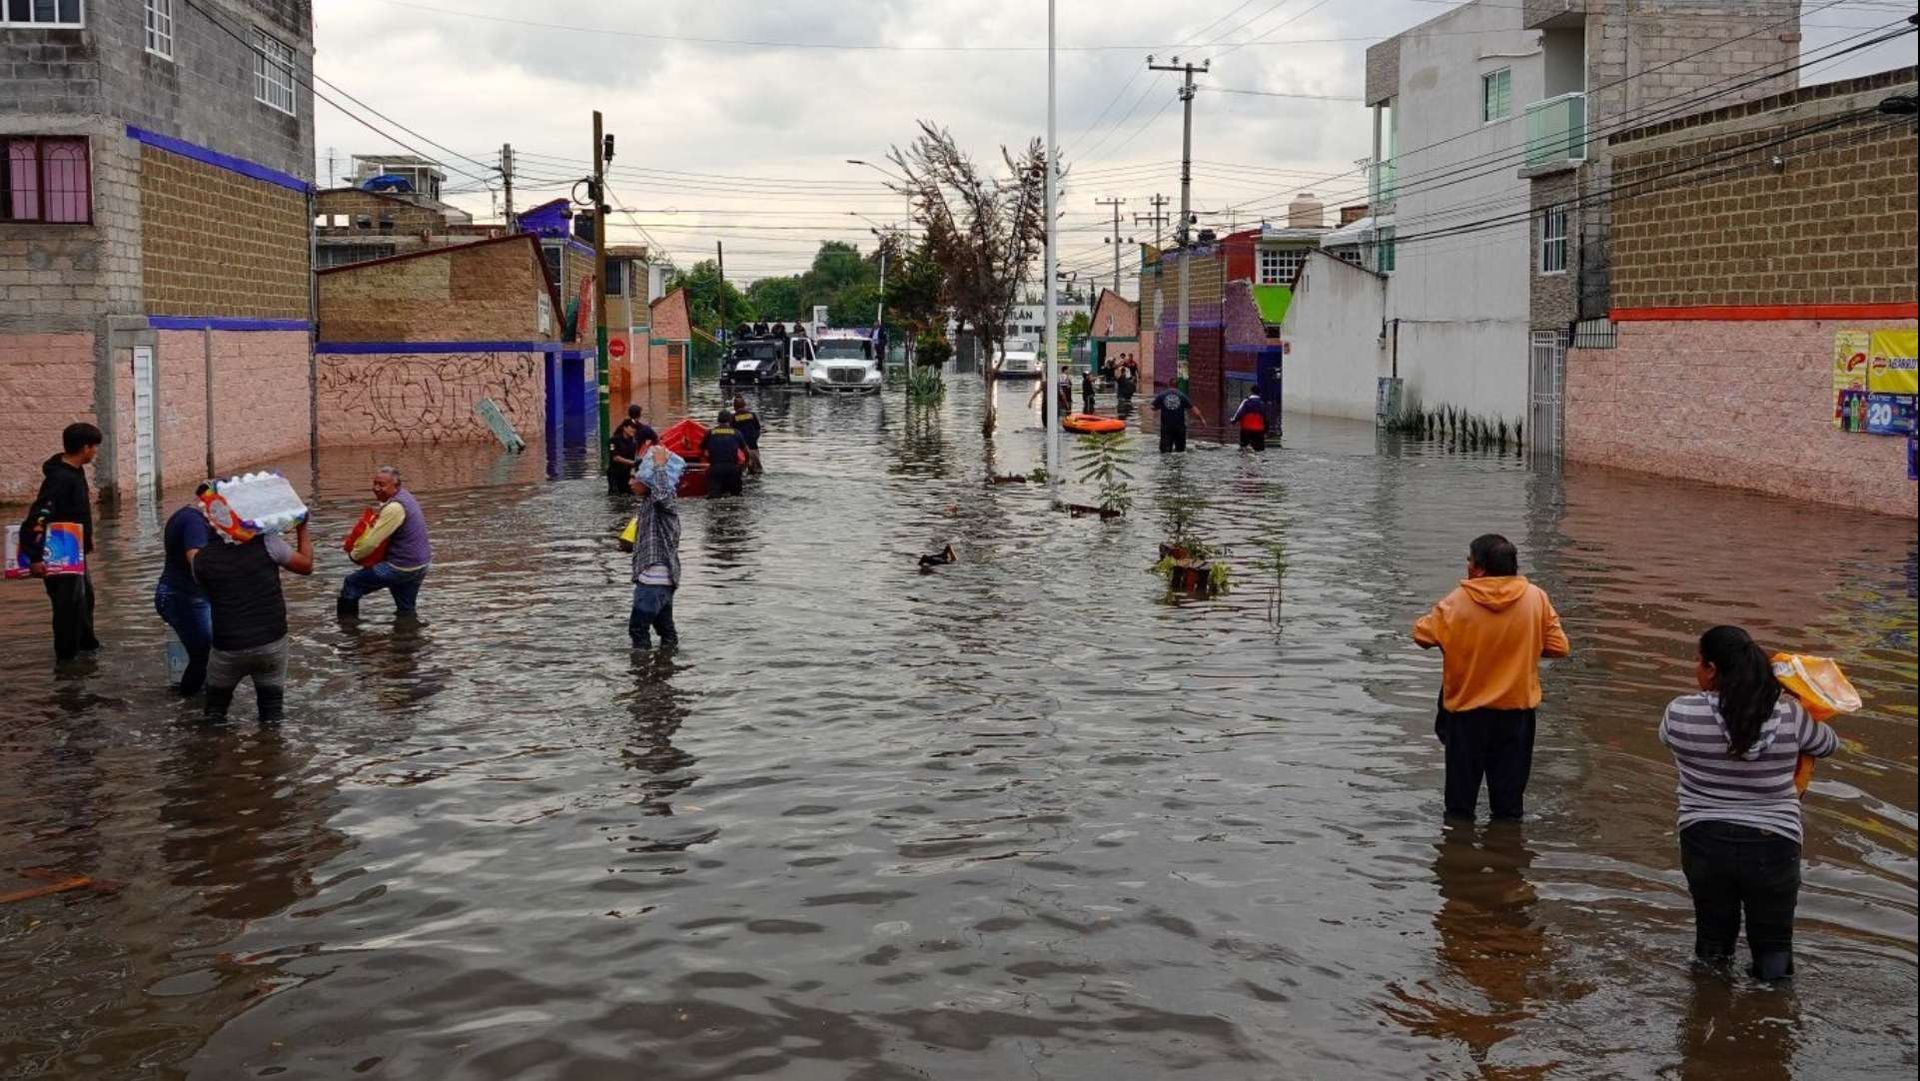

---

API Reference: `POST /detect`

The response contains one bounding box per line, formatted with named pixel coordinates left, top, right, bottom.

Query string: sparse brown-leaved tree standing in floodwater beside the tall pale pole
left=887, top=121, right=1052, bottom=438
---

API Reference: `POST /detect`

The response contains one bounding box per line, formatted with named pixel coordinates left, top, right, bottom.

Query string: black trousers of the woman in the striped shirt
left=1680, top=822, right=1801, bottom=979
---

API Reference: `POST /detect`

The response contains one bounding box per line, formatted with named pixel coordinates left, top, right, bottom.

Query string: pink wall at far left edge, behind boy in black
left=0, top=332, right=100, bottom=503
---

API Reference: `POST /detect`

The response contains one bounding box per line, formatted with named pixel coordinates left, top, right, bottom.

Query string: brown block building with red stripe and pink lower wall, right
left=1567, top=67, right=1920, bottom=518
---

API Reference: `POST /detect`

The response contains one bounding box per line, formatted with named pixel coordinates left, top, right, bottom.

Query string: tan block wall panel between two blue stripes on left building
left=140, top=146, right=311, bottom=319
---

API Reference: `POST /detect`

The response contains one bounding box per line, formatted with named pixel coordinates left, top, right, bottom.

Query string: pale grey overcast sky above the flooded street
left=315, top=0, right=1914, bottom=282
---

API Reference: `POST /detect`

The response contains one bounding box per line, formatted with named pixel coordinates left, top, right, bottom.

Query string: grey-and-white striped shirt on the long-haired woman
left=1661, top=691, right=1839, bottom=841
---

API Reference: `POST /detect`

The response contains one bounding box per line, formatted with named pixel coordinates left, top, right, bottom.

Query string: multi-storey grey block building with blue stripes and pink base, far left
left=0, top=0, right=313, bottom=499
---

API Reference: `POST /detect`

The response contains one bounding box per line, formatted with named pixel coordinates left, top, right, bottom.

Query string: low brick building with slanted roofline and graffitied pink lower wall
left=315, top=234, right=560, bottom=447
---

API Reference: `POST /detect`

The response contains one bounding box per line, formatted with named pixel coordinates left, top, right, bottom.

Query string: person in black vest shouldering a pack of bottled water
left=194, top=522, right=313, bottom=724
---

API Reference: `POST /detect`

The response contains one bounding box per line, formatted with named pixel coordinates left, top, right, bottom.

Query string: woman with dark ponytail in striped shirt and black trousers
left=1661, top=626, right=1839, bottom=979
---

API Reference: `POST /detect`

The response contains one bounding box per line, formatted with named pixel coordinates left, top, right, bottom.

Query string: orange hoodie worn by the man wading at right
left=1413, top=576, right=1572, bottom=712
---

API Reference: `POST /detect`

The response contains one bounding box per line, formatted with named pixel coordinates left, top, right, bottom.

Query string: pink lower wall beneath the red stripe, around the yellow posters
left=1567, top=319, right=1916, bottom=518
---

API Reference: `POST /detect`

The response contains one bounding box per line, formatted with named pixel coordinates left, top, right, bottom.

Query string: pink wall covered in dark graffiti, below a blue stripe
left=319, top=353, right=547, bottom=447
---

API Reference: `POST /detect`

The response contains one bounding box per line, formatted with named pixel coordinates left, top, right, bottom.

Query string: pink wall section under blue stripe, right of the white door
left=202, top=330, right=311, bottom=472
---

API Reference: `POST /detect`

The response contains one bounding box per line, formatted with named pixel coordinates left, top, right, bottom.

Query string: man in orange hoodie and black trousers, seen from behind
left=1413, top=534, right=1572, bottom=820
